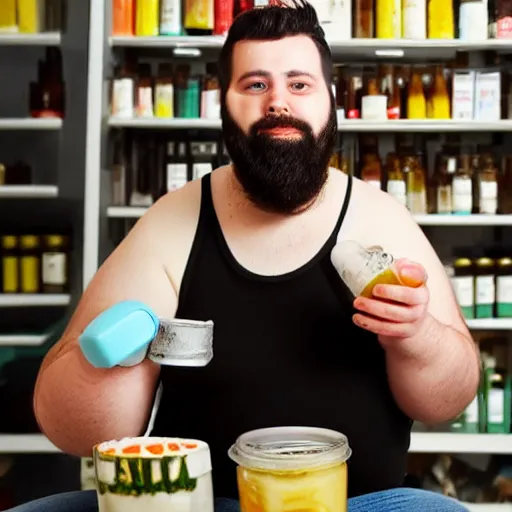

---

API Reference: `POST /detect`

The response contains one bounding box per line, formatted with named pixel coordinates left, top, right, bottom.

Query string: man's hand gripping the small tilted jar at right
left=353, top=259, right=430, bottom=348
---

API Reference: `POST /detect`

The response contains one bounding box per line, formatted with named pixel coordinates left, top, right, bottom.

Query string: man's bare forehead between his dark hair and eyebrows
left=233, top=36, right=321, bottom=74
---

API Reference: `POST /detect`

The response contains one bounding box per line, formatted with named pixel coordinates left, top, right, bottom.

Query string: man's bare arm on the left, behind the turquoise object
left=34, top=200, right=177, bottom=456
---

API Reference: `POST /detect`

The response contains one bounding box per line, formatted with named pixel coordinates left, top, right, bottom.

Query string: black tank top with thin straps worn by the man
left=151, top=175, right=412, bottom=498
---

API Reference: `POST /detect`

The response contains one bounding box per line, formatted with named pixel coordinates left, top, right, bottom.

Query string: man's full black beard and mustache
left=222, top=105, right=337, bottom=214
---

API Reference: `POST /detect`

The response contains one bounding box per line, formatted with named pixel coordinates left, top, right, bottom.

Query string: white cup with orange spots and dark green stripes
left=94, top=437, right=214, bottom=512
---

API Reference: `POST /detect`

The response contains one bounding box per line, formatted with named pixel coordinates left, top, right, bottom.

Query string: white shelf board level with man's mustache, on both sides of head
left=108, top=117, right=512, bottom=133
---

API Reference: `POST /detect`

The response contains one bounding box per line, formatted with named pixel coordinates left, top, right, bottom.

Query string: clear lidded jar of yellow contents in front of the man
left=228, top=427, right=352, bottom=512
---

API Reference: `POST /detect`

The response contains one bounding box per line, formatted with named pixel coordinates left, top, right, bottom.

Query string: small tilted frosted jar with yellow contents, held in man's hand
left=331, top=240, right=406, bottom=297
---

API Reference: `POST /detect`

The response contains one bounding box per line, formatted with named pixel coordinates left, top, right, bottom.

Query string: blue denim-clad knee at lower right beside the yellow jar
left=349, top=488, right=468, bottom=512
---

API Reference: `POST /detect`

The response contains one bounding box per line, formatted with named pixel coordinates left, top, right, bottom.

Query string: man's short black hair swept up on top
left=218, top=0, right=332, bottom=103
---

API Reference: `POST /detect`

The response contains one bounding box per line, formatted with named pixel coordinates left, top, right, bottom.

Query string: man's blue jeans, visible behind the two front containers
left=6, top=488, right=467, bottom=512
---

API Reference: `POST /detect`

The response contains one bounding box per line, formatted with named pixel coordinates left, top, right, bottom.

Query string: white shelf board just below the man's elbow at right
left=409, top=432, right=512, bottom=454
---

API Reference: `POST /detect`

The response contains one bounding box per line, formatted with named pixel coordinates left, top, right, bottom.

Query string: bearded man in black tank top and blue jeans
left=12, top=2, right=479, bottom=512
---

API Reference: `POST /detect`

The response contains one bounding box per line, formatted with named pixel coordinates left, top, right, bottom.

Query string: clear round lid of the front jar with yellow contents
left=228, top=427, right=352, bottom=471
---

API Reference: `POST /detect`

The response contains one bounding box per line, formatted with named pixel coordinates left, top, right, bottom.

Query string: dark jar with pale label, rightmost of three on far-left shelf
left=41, top=235, right=69, bottom=293
